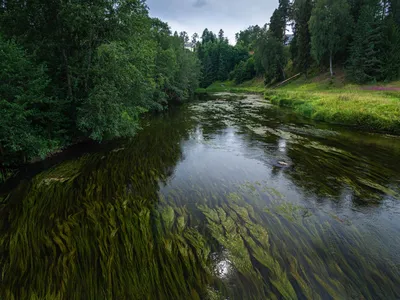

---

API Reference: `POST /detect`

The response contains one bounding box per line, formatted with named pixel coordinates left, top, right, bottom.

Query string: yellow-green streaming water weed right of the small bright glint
left=199, top=184, right=399, bottom=299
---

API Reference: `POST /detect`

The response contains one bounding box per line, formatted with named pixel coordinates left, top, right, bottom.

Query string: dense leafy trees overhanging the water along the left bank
left=0, top=0, right=200, bottom=166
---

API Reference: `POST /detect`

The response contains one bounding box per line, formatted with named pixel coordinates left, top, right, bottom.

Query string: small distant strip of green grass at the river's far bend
left=196, top=78, right=265, bottom=94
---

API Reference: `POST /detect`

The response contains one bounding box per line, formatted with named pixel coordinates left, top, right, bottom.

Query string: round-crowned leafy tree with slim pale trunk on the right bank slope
left=309, top=0, right=353, bottom=76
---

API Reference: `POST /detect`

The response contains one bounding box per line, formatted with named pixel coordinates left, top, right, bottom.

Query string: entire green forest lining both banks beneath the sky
left=0, top=0, right=400, bottom=167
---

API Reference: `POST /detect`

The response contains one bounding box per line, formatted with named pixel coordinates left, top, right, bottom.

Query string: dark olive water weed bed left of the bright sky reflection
left=0, top=113, right=217, bottom=299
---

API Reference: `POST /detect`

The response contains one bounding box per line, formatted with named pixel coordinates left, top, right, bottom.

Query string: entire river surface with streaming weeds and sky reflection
left=0, top=95, right=400, bottom=299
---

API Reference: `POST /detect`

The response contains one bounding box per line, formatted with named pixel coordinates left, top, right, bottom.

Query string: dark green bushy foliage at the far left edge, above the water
left=0, top=37, right=63, bottom=165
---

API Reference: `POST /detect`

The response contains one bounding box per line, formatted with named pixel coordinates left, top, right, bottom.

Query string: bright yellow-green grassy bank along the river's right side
left=265, top=79, right=400, bottom=134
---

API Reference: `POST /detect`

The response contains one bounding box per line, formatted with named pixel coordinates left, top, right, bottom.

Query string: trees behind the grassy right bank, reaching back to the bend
left=195, top=0, right=400, bottom=86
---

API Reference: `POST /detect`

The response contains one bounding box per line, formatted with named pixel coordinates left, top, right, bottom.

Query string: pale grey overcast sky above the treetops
left=147, top=0, right=278, bottom=44
